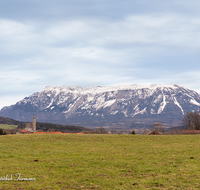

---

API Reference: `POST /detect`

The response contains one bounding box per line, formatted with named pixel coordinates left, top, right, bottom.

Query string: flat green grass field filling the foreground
left=0, top=134, right=200, bottom=190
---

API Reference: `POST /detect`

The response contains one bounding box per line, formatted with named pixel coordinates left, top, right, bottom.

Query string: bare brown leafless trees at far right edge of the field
left=182, top=111, right=200, bottom=130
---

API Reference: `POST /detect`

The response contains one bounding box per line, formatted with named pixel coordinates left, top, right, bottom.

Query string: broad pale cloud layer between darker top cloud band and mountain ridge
left=0, top=5, right=200, bottom=108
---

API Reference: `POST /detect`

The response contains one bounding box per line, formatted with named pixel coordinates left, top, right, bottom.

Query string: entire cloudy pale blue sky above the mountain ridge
left=0, top=0, right=200, bottom=109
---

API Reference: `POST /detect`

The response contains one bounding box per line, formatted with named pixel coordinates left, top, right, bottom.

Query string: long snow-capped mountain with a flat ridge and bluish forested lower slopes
left=0, top=84, right=200, bottom=127
